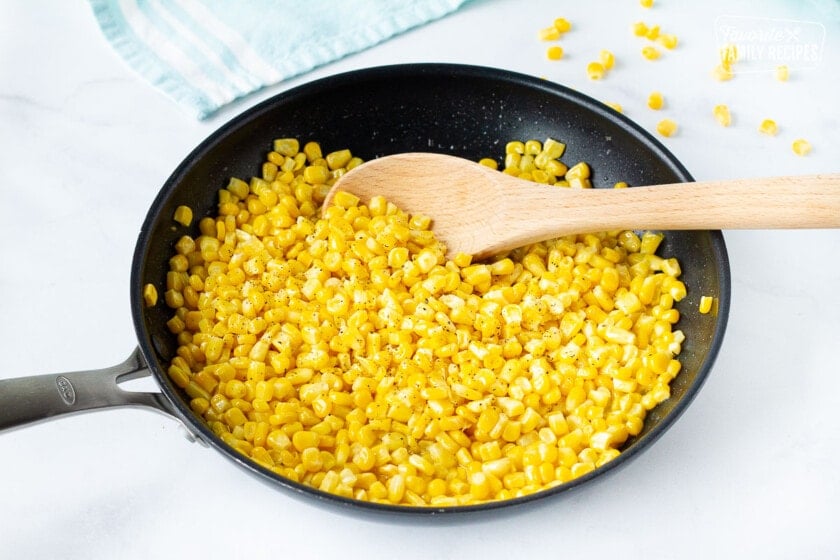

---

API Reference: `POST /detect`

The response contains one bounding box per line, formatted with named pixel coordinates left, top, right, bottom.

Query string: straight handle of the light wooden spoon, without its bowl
left=517, top=174, right=840, bottom=237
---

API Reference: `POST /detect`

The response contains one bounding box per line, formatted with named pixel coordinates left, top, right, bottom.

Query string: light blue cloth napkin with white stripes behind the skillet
left=89, top=0, right=467, bottom=119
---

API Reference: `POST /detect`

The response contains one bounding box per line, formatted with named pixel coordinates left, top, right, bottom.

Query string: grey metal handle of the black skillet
left=0, top=348, right=175, bottom=432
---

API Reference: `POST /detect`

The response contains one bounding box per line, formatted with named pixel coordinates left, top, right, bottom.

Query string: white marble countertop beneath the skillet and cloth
left=0, top=0, right=840, bottom=560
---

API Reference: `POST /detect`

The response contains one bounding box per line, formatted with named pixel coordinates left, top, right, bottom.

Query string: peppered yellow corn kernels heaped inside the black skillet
left=151, top=138, right=686, bottom=507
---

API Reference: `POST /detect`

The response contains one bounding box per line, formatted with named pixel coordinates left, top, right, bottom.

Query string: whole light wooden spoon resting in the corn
left=324, top=153, right=840, bottom=259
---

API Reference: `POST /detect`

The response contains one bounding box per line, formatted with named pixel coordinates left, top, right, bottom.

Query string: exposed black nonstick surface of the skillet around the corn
left=131, top=64, right=730, bottom=515
